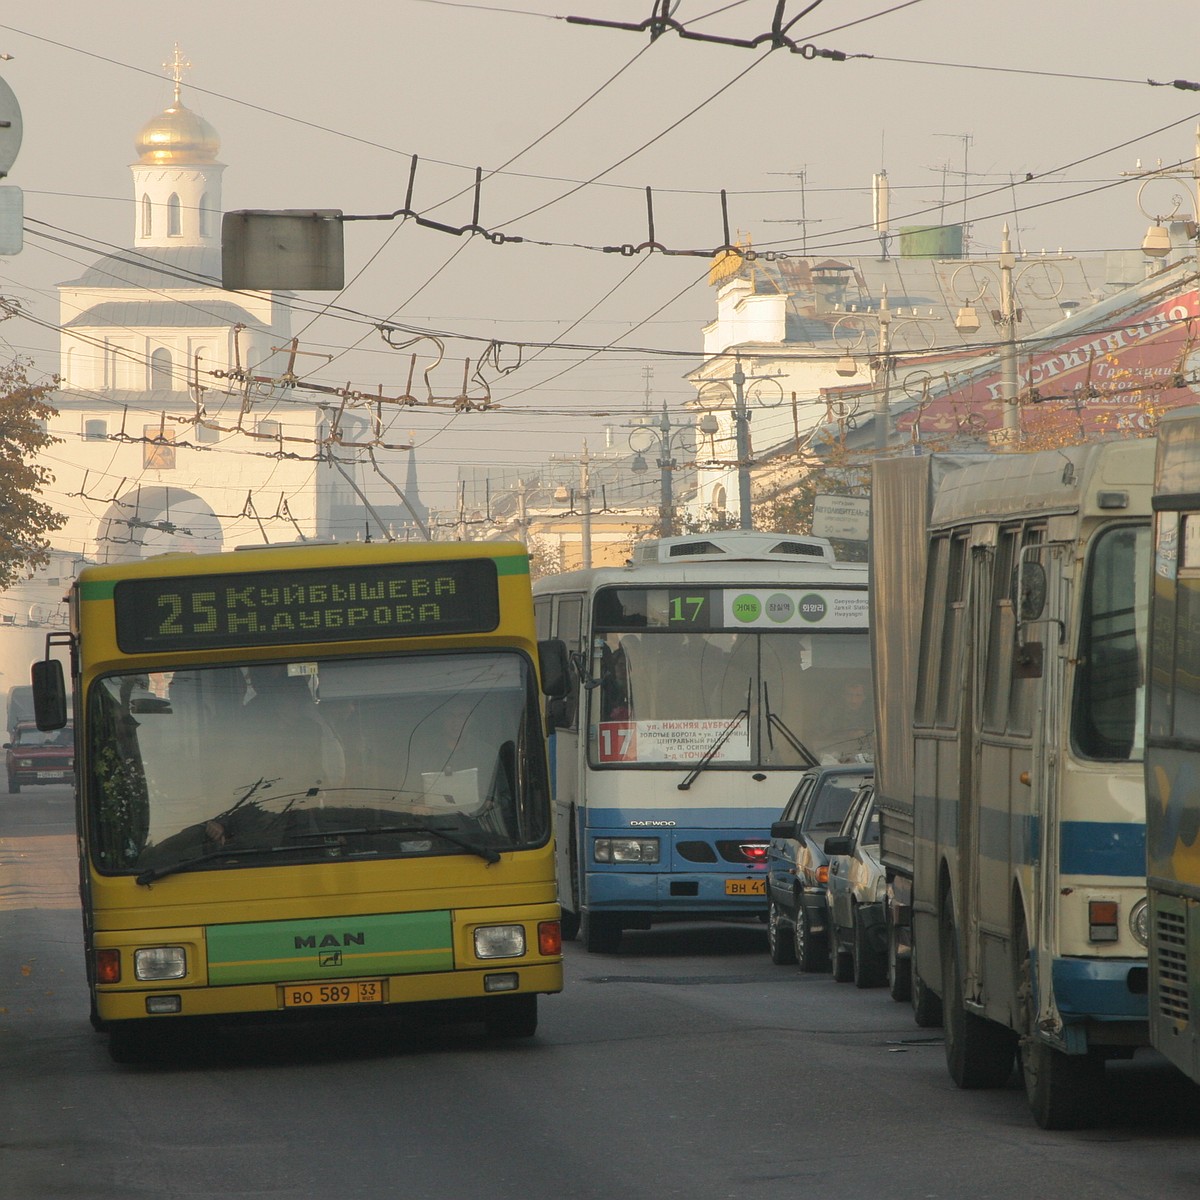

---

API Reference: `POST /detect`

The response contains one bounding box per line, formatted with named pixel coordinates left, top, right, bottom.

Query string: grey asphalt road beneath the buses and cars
left=0, top=788, right=1200, bottom=1200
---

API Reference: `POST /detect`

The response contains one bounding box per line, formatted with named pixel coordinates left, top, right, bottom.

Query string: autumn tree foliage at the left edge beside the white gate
left=0, top=359, right=66, bottom=589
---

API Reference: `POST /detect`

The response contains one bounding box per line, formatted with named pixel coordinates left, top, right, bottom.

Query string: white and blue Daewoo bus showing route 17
left=534, top=530, right=874, bottom=953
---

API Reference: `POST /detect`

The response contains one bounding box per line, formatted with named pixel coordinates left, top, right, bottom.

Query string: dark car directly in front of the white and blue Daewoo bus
left=767, top=763, right=872, bottom=971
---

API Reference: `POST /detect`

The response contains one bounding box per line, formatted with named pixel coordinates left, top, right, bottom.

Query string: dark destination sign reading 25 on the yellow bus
left=106, top=558, right=500, bottom=654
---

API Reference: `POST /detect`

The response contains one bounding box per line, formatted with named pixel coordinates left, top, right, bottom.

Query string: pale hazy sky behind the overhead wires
left=0, top=0, right=1200, bottom=505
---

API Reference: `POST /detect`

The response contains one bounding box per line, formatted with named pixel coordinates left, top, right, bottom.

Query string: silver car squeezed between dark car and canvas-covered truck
left=824, top=781, right=888, bottom=988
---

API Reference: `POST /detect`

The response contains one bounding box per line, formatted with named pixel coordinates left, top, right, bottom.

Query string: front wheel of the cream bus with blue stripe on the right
left=1015, top=926, right=1104, bottom=1129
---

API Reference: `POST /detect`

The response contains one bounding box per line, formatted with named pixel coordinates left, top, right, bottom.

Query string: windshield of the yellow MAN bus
left=88, top=652, right=548, bottom=882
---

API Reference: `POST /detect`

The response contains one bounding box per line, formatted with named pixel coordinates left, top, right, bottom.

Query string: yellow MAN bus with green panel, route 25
left=34, top=545, right=566, bottom=1061
